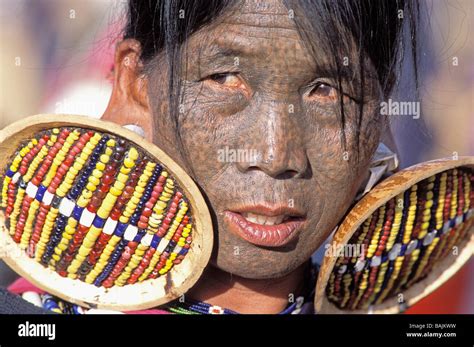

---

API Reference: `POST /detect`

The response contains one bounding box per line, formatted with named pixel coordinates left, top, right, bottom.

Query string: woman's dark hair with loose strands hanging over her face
left=124, top=0, right=419, bottom=152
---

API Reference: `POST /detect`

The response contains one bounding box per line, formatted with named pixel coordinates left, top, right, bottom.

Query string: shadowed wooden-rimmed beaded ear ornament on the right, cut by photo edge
left=315, top=157, right=474, bottom=313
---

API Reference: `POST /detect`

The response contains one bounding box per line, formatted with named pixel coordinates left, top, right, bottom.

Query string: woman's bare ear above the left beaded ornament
left=102, top=39, right=153, bottom=141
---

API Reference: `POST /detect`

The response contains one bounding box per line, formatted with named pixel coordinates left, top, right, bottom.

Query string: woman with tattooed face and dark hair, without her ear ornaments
left=2, top=0, right=417, bottom=313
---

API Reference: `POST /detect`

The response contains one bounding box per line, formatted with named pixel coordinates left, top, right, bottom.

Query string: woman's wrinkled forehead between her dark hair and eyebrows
left=188, top=0, right=314, bottom=68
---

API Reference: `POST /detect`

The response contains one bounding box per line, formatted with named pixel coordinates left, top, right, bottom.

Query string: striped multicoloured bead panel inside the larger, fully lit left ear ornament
left=0, top=127, right=193, bottom=288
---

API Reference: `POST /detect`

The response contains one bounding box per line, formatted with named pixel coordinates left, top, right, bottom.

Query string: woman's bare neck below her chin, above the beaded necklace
left=187, top=264, right=307, bottom=314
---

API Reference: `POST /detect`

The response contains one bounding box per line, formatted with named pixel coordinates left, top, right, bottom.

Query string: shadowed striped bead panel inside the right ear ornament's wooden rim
left=326, top=168, right=474, bottom=310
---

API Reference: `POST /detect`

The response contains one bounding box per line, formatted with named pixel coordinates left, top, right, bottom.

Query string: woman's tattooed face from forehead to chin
left=148, top=1, right=382, bottom=278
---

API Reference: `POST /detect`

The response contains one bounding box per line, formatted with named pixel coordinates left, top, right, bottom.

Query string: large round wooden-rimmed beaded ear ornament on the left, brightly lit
left=0, top=115, right=213, bottom=311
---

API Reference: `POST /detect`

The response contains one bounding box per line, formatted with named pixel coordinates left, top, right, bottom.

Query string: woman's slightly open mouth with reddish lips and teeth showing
left=224, top=206, right=306, bottom=247
